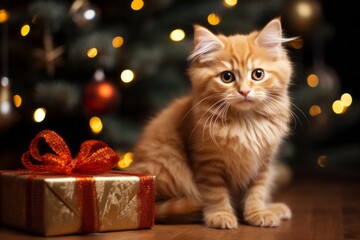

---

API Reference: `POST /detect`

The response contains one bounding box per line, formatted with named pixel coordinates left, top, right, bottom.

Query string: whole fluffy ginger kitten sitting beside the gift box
left=129, top=19, right=292, bottom=229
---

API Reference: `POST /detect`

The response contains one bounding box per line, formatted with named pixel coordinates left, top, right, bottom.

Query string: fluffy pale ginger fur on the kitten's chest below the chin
left=187, top=102, right=288, bottom=189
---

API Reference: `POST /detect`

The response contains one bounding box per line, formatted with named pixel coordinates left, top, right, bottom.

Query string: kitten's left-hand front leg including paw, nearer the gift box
left=196, top=160, right=238, bottom=229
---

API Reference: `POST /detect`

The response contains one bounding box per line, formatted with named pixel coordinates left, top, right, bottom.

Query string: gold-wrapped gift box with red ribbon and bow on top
left=0, top=129, right=154, bottom=236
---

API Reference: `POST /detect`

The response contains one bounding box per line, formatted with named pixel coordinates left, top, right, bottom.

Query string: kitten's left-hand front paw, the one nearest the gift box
left=204, top=211, right=238, bottom=229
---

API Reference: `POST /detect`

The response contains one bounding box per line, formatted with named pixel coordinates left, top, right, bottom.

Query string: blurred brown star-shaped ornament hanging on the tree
left=33, top=28, right=65, bottom=77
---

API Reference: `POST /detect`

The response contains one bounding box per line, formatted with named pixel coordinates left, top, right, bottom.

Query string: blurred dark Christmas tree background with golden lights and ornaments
left=0, top=0, right=360, bottom=178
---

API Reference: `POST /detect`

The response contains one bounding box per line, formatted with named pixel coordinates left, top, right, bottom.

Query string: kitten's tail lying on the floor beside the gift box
left=155, top=198, right=202, bottom=224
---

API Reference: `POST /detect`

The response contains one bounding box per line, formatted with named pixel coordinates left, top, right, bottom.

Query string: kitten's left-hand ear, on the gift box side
left=188, top=25, right=224, bottom=62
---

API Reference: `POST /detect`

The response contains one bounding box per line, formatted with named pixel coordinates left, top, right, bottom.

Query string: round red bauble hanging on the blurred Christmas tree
left=83, top=69, right=120, bottom=115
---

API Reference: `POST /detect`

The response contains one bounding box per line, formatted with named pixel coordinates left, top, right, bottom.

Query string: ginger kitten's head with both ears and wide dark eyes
left=189, top=20, right=291, bottom=111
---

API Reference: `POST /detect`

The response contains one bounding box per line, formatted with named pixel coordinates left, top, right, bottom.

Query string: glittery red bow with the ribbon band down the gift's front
left=21, top=130, right=119, bottom=233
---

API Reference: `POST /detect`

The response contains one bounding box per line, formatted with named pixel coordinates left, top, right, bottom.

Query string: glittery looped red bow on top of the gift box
left=21, top=130, right=119, bottom=175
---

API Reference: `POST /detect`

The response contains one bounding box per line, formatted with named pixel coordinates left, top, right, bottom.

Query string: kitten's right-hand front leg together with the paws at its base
left=244, top=169, right=291, bottom=227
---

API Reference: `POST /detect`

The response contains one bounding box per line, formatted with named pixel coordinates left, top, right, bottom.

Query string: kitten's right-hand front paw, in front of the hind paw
left=244, top=209, right=281, bottom=227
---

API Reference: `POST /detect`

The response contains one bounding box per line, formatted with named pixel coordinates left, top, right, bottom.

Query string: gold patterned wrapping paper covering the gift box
left=0, top=172, right=154, bottom=236
